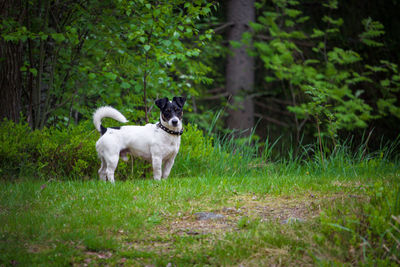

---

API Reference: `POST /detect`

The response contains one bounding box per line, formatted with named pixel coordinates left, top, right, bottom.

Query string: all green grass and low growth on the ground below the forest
left=0, top=120, right=400, bottom=266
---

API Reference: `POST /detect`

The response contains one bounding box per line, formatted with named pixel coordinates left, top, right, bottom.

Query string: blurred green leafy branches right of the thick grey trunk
left=250, top=0, right=400, bottom=147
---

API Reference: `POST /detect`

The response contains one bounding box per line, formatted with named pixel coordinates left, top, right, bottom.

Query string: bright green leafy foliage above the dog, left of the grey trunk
left=0, top=0, right=213, bottom=128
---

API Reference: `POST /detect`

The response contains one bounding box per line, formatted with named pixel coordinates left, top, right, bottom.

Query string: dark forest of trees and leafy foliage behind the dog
left=0, top=0, right=400, bottom=161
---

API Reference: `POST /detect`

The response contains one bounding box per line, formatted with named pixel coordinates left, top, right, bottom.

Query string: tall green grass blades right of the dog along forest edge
left=183, top=118, right=400, bottom=181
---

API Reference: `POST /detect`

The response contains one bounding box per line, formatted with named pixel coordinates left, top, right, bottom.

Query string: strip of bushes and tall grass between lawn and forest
left=0, top=120, right=399, bottom=180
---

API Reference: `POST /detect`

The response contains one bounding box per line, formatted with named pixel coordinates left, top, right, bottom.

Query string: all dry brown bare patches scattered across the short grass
left=122, top=193, right=360, bottom=266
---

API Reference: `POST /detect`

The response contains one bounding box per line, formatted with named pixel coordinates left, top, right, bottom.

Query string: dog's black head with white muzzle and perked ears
left=156, top=97, right=186, bottom=127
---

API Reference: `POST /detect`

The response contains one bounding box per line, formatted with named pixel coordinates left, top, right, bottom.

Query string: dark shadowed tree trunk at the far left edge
left=0, top=0, right=22, bottom=122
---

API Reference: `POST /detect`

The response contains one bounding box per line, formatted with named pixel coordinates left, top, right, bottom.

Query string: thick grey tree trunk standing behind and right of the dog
left=226, top=0, right=255, bottom=135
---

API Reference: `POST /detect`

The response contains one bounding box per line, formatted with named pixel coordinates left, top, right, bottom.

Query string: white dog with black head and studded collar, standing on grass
left=93, top=97, right=186, bottom=183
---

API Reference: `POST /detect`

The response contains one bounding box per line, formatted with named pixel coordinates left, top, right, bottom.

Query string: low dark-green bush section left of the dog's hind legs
left=0, top=120, right=97, bottom=178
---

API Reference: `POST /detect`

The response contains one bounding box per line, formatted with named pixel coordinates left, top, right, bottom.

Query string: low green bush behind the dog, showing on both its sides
left=0, top=120, right=217, bottom=179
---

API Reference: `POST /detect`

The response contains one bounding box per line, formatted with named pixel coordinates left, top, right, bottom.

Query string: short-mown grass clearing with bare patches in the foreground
left=0, top=160, right=400, bottom=266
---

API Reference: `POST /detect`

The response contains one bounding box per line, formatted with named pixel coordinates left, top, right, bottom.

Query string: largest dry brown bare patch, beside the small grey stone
left=157, top=194, right=341, bottom=238
